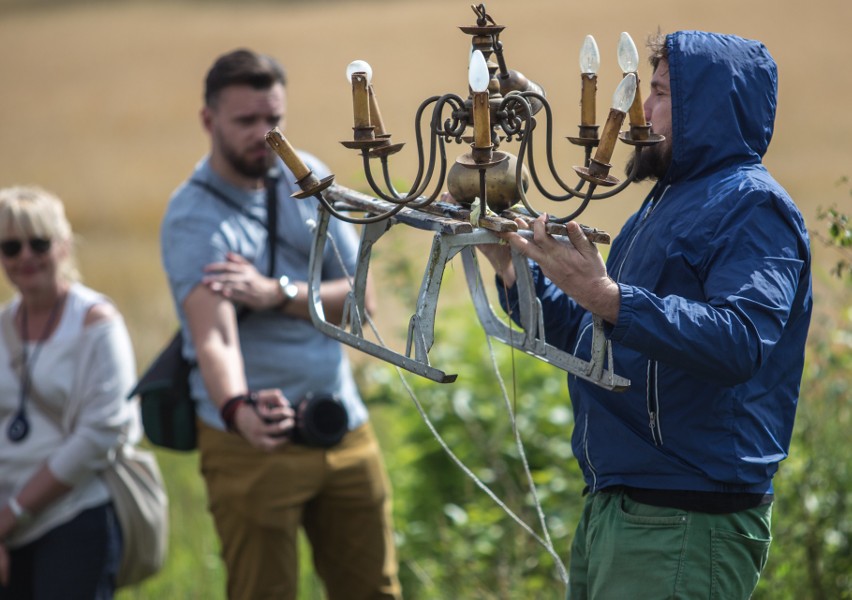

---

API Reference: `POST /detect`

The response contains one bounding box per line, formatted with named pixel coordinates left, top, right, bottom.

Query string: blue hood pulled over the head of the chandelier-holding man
left=666, top=31, right=778, bottom=182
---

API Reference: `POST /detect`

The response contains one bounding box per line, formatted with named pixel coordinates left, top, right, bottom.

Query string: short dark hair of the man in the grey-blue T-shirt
left=204, top=48, right=287, bottom=106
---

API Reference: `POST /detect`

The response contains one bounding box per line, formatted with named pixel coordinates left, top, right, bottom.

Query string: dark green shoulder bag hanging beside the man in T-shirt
left=129, top=330, right=198, bottom=451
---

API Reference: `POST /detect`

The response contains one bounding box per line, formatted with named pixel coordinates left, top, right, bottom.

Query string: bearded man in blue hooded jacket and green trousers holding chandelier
left=480, top=31, right=812, bottom=600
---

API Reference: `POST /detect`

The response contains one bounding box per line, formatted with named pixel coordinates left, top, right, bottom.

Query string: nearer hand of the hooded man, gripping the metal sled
left=500, top=214, right=621, bottom=323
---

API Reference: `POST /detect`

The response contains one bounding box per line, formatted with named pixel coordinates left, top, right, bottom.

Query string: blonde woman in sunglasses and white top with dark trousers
left=0, top=187, right=140, bottom=600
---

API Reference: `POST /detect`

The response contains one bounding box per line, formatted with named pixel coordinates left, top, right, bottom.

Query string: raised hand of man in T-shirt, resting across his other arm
left=201, top=252, right=283, bottom=310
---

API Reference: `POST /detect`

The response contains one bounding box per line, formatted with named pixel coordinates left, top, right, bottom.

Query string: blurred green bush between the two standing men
left=361, top=309, right=583, bottom=599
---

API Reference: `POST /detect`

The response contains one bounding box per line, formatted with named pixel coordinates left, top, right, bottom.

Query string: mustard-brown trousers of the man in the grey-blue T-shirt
left=199, top=423, right=401, bottom=600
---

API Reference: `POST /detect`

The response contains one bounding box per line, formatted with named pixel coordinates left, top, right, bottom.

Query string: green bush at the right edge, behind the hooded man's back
left=755, top=302, right=852, bottom=600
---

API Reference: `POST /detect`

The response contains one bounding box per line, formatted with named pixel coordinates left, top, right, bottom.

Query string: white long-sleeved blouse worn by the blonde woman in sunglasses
left=0, top=283, right=140, bottom=547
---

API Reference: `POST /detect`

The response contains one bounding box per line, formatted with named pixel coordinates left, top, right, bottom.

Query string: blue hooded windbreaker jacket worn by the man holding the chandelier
left=506, top=31, right=812, bottom=493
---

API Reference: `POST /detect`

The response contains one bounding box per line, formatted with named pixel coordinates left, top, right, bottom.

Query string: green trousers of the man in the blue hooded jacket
left=568, top=491, right=772, bottom=600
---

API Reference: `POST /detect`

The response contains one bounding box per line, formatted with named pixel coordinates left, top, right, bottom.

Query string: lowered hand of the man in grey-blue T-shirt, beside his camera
left=234, top=390, right=295, bottom=451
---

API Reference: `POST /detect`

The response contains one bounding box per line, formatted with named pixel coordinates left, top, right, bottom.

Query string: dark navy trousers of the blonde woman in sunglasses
left=0, top=502, right=122, bottom=600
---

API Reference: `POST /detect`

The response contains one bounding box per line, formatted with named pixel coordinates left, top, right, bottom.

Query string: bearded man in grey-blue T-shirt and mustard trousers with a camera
left=161, top=50, right=401, bottom=600
